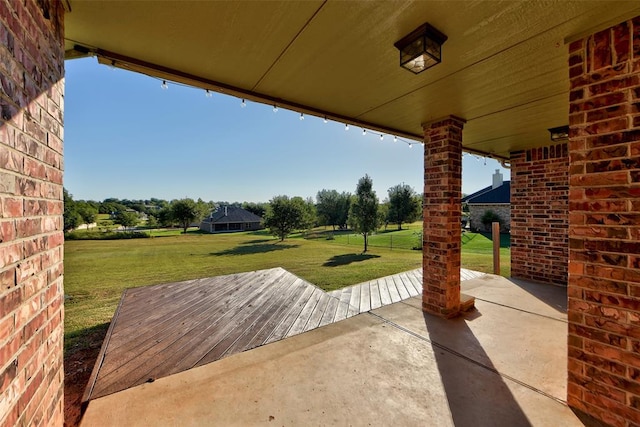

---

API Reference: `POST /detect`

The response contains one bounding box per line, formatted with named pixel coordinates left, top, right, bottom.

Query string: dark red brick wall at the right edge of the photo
left=568, top=17, right=640, bottom=426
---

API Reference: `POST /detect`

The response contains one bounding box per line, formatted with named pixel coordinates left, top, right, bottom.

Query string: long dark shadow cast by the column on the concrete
left=424, top=310, right=531, bottom=427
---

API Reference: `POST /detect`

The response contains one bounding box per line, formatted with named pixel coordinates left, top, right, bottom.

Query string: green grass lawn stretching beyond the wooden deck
left=65, top=225, right=509, bottom=351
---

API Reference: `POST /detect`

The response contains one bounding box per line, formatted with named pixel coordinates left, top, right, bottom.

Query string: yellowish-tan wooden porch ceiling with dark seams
left=65, top=0, right=640, bottom=158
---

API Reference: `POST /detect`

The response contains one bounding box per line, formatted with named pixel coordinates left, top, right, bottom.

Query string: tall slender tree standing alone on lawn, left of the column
left=349, top=175, right=380, bottom=252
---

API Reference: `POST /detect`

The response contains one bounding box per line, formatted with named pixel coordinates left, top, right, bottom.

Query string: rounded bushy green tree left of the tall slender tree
left=263, top=196, right=311, bottom=242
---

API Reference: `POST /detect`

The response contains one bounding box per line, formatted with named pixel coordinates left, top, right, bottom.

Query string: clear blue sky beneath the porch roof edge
left=64, top=58, right=509, bottom=202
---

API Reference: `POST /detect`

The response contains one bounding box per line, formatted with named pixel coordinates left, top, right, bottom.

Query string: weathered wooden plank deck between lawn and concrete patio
left=83, top=268, right=482, bottom=402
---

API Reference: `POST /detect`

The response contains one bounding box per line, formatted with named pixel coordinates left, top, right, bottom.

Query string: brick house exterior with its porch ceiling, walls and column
left=0, top=0, right=640, bottom=426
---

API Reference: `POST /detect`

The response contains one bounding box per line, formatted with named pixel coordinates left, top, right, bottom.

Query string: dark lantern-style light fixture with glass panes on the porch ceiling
left=394, top=23, right=447, bottom=74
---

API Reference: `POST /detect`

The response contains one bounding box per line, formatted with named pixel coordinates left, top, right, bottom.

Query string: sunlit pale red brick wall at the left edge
left=0, top=0, right=64, bottom=426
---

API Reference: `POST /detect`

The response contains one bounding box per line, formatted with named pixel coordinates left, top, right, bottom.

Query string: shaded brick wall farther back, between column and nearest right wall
left=511, top=144, right=569, bottom=285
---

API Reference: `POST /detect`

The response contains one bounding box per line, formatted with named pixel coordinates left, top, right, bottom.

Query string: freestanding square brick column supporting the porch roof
left=422, top=116, right=465, bottom=317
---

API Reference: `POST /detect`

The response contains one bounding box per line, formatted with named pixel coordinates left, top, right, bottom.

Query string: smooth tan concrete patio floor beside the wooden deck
left=82, top=275, right=582, bottom=426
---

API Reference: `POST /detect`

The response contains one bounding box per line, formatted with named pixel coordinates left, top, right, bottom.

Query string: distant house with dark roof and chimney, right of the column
left=462, top=169, right=511, bottom=231
